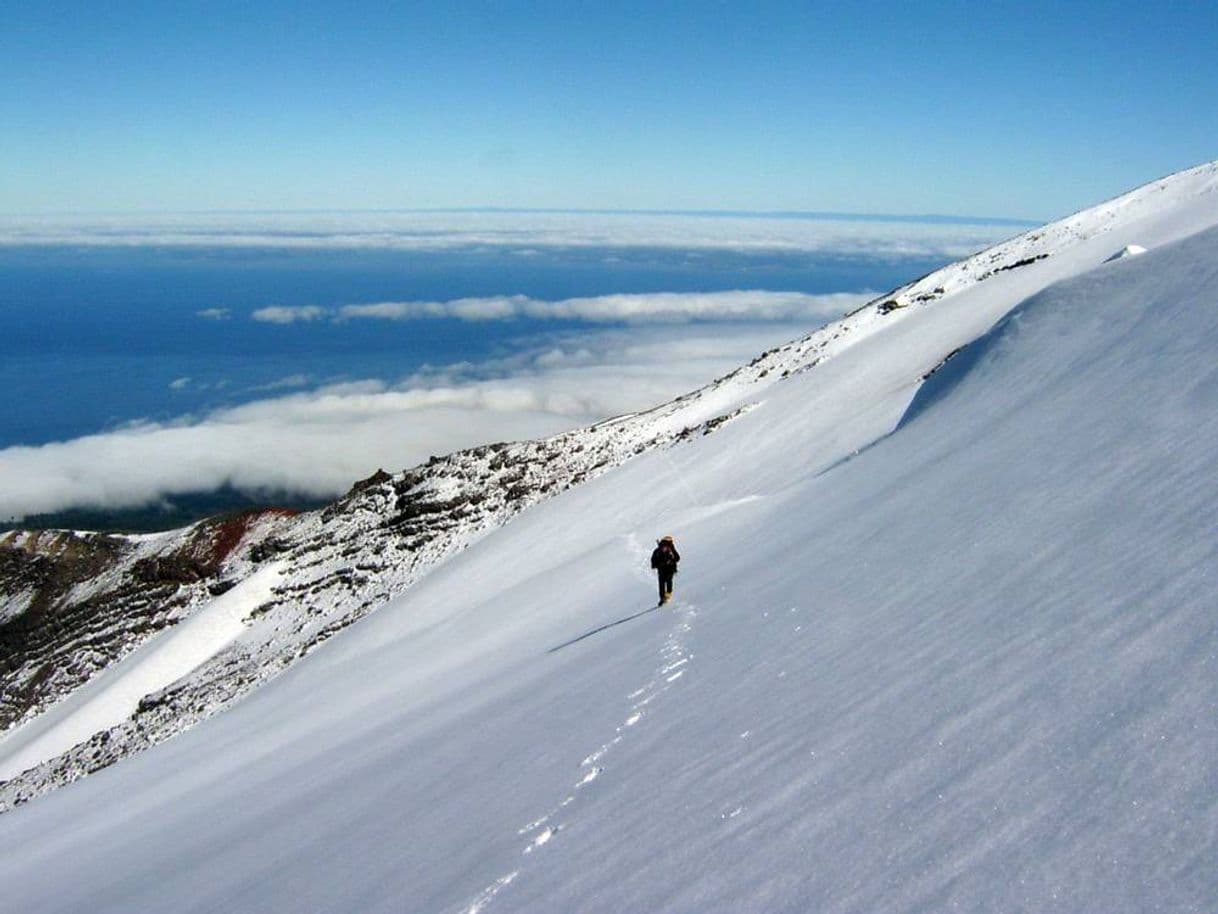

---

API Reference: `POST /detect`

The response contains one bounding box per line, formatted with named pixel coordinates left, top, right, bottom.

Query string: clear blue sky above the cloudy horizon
left=0, top=1, right=1218, bottom=219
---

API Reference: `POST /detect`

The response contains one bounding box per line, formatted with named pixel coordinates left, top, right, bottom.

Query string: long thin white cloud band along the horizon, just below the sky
left=0, top=212, right=1019, bottom=260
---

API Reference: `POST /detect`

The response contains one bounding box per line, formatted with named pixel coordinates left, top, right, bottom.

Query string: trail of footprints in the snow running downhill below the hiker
left=462, top=603, right=701, bottom=914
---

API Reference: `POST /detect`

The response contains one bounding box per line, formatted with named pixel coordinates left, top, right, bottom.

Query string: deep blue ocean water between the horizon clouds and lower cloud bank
left=0, top=240, right=942, bottom=447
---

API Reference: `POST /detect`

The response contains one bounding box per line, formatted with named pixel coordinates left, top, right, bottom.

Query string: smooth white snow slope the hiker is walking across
left=0, top=160, right=1218, bottom=912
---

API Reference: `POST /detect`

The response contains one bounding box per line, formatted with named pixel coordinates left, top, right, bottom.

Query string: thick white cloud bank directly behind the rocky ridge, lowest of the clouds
left=0, top=322, right=806, bottom=517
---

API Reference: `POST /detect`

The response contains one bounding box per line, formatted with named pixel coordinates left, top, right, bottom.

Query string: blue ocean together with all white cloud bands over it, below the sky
left=0, top=212, right=1016, bottom=529
